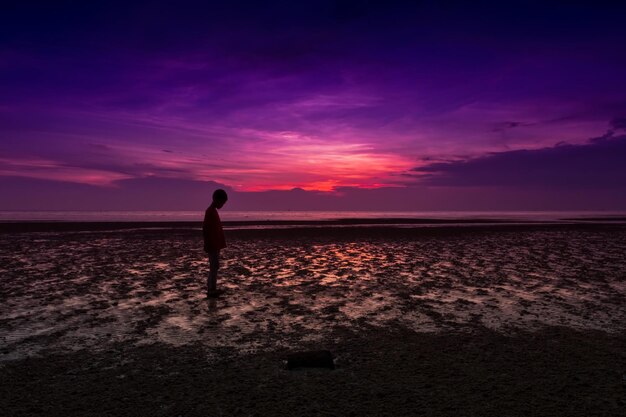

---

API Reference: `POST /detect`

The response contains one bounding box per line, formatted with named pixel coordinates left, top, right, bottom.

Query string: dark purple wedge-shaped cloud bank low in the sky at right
left=414, top=133, right=626, bottom=187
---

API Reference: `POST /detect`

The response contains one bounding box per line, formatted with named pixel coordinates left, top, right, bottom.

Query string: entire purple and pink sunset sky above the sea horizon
left=0, top=0, right=626, bottom=210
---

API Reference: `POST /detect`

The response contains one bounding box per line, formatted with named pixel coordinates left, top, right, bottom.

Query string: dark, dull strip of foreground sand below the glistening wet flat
left=0, top=328, right=626, bottom=417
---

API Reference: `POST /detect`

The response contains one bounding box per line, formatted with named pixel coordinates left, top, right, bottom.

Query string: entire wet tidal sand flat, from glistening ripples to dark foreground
left=0, top=224, right=626, bottom=416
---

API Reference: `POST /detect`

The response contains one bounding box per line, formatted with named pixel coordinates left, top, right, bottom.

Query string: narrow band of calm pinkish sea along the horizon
left=0, top=209, right=626, bottom=222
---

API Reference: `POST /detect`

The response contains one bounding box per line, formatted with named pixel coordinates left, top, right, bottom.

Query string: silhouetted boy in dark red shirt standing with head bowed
left=202, top=189, right=228, bottom=297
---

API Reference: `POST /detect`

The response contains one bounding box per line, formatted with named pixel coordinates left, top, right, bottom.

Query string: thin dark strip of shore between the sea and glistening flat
left=0, top=217, right=626, bottom=233
